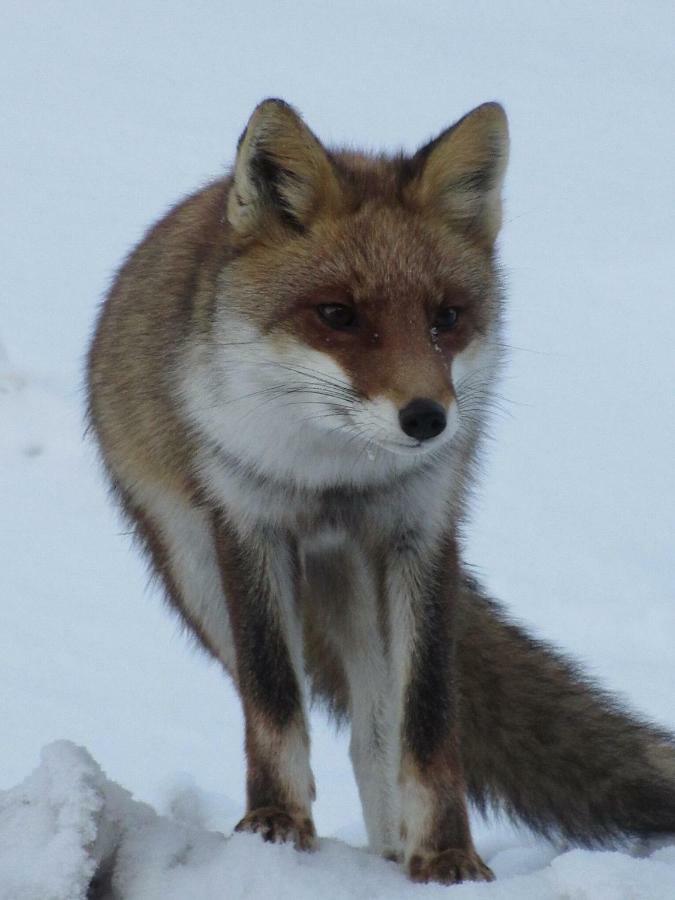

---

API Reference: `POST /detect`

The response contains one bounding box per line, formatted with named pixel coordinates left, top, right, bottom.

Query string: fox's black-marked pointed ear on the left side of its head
left=227, top=100, right=339, bottom=237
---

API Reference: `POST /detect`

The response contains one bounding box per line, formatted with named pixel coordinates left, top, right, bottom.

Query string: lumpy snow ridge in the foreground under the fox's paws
left=0, top=741, right=675, bottom=900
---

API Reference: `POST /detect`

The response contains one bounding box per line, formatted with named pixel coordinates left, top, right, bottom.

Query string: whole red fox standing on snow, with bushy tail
left=87, top=99, right=675, bottom=884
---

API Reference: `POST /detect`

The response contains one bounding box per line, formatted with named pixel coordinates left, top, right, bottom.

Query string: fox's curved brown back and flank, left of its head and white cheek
left=88, top=179, right=228, bottom=496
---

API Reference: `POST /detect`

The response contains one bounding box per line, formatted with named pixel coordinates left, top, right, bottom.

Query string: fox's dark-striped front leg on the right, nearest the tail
left=388, top=541, right=494, bottom=884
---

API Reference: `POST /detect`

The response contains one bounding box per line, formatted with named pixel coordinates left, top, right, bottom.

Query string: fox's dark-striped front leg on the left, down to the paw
left=215, top=516, right=316, bottom=850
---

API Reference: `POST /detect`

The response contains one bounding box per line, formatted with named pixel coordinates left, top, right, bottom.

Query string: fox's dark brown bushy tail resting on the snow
left=458, top=580, right=675, bottom=845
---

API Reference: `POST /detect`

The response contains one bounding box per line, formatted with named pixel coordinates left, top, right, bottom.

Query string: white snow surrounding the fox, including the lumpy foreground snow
left=0, top=0, right=675, bottom=900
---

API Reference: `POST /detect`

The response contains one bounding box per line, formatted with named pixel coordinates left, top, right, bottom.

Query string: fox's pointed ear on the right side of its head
left=410, top=103, right=509, bottom=246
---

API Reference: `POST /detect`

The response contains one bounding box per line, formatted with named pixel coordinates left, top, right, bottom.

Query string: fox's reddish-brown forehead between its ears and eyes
left=228, top=198, right=495, bottom=315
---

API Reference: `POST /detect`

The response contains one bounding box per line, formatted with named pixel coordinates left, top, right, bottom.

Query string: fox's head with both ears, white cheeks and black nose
left=185, top=100, right=508, bottom=481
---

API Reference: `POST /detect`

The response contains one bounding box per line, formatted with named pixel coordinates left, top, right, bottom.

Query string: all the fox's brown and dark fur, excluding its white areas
left=89, top=102, right=675, bottom=883
